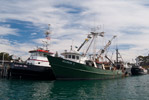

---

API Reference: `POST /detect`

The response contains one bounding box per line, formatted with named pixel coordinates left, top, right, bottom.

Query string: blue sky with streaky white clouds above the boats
left=0, top=0, right=149, bottom=61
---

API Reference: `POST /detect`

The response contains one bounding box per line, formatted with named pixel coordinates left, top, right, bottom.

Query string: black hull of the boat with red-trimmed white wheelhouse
left=8, top=63, right=55, bottom=80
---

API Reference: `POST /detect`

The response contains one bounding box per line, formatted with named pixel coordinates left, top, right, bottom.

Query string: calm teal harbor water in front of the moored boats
left=0, top=75, right=149, bottom=100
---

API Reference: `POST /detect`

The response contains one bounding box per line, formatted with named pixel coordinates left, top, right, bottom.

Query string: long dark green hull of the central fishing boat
left=48, top=56, right=122, bottom=80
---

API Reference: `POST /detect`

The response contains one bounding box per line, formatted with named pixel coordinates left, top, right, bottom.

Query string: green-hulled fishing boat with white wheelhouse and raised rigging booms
left=47, top=28, right=123, bottom=80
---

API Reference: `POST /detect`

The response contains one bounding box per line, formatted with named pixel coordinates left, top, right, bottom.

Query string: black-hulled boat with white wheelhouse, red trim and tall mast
left=8, top=24, right=55, bottom=80
